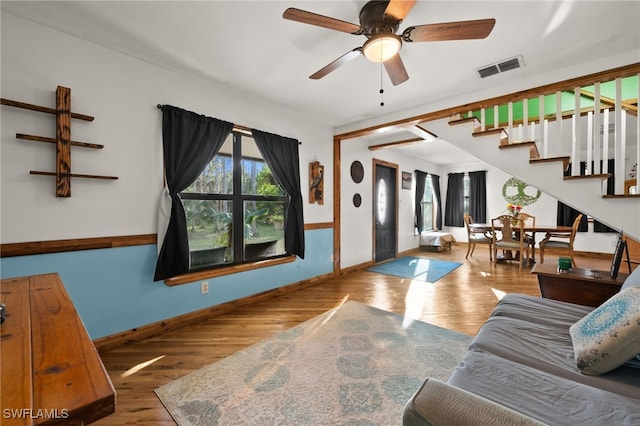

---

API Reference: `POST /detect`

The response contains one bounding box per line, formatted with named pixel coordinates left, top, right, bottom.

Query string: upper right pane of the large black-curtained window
left=242, top=137, right=284, bottom=196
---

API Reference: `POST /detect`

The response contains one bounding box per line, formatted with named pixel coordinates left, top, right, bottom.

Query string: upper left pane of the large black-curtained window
left=184, top=135, right=233, bottom=194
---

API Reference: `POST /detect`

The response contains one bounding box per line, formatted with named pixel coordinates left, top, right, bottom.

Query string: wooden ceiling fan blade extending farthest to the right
left=402, top=18, right=496, bottom=41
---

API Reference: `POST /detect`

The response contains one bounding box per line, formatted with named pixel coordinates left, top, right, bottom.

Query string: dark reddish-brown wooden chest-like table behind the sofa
left=531, top=264, right=628, bottom=307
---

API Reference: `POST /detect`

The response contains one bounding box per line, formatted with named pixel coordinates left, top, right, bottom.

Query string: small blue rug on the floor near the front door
left=367, top=256, right=462, bottom=283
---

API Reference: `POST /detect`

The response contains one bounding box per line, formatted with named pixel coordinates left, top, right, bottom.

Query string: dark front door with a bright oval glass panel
left=373, top=164, right=398, bottom=263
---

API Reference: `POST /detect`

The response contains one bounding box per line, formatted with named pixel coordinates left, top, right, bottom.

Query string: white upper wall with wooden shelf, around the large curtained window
left=0, top=13, right=333, bottom=243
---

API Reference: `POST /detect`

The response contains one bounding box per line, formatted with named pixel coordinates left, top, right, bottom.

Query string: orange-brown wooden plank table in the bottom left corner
left=0, top=274, right=115, bottom=426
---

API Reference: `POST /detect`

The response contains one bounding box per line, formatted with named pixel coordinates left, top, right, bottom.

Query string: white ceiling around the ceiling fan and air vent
left=1, top=0, right=640, bottom=162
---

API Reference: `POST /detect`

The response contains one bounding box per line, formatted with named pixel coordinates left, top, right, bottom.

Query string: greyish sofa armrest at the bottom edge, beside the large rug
left=402, top=378, right=544, bottom=426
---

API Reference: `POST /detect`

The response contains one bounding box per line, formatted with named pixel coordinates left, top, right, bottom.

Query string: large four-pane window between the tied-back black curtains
left=180, top=132, right=289, bottom=271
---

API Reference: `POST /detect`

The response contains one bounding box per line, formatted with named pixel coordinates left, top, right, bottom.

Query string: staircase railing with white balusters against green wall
left=451, top=68, right=640, bottom=195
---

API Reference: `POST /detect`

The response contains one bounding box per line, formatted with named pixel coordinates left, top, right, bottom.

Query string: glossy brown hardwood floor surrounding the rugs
left=94, top=243, right=610, bottom=426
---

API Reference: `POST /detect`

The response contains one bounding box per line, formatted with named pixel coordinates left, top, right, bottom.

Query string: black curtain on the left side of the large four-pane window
left=153, top=105, right=233, bottom=281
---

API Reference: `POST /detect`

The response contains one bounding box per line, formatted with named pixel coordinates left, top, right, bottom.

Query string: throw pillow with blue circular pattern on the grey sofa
left=569, top=287, right=640, bottom=375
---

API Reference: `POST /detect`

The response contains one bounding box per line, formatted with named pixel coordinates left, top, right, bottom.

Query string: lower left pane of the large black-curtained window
left=182, top=200, right=233, bottom=269
